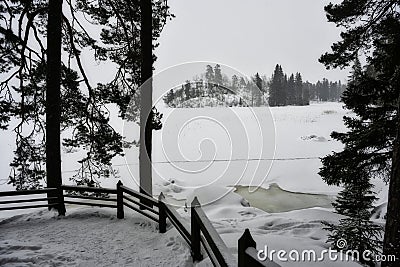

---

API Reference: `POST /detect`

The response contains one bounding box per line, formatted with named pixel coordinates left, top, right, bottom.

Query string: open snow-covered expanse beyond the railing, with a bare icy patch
left=0, top=103, right=387, bottom=266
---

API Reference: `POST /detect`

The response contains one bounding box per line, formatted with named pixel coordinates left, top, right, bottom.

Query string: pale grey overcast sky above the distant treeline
left=155, top=0, right=348, bottom=82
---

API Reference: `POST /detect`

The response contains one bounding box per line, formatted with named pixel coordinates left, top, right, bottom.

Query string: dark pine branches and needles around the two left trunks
left=0, top=0, right=171, bottom=190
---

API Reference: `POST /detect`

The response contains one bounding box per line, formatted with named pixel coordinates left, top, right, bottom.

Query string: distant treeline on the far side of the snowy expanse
left=164, top=64, right=345, bottom=107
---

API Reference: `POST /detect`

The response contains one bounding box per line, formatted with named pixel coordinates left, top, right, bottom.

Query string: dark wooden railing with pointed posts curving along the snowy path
left=0, top=181, right=279, bottom=267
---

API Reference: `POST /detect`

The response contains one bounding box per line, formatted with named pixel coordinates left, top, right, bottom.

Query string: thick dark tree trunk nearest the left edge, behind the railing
left=46, top=0, right=65, bottom=215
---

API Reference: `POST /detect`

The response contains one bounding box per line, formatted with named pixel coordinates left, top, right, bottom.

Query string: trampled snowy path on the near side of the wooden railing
left=0, top=208, right=193, bottom=266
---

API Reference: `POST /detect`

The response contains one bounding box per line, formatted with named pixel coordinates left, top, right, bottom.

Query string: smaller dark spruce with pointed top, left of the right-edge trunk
left=320, top=61, right=384, bottom=264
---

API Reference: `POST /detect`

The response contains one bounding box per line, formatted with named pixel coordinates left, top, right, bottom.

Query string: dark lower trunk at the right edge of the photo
left=382, top=97, right=400, bottom=267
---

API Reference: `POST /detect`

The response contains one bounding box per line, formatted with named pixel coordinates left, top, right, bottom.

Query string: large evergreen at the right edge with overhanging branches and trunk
left=320, top=0, right=400, bottom=266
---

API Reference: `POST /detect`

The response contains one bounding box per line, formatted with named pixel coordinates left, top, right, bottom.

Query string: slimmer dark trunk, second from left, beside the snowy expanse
left=139, top=0, right=153, bottom=206
